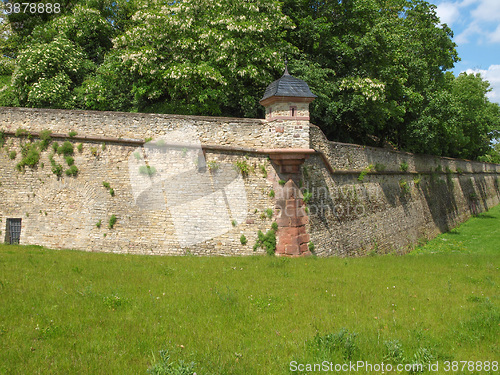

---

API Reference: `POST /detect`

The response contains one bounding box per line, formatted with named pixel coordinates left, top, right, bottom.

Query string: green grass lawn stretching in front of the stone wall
left=0, top=206, right=500, bottom=375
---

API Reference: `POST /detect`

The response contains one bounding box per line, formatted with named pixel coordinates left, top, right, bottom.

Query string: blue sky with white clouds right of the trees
left=429, top=0, right=500, bottom=104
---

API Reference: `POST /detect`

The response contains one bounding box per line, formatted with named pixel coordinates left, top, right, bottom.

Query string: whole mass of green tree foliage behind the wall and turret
left=0, top=0, right=500, bottom=162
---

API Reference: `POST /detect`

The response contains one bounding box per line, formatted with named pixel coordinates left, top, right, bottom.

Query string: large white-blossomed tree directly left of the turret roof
left=106, top=0, right=292, bottom=116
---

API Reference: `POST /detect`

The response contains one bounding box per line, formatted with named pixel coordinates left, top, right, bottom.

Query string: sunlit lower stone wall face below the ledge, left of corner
left=0, top=137, right=282, bottom=255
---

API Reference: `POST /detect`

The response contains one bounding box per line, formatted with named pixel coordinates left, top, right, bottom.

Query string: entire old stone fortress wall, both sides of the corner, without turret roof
left=0, top=108, right=500, bottom=256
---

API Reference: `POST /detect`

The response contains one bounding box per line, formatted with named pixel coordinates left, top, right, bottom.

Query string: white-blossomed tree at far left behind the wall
left=4, top=1, right=126, bottom=108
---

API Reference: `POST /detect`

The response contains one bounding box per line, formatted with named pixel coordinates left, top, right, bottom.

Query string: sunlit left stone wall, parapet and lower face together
left=0, top=108, right=292, bottom=255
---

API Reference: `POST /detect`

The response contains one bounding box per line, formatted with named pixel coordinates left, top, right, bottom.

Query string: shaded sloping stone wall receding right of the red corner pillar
left=303, top=127, right=500, bottom=256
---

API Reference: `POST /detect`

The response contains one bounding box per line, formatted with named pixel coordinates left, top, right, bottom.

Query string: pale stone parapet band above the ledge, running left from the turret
left=0, top=107, right=309, bottom=148
